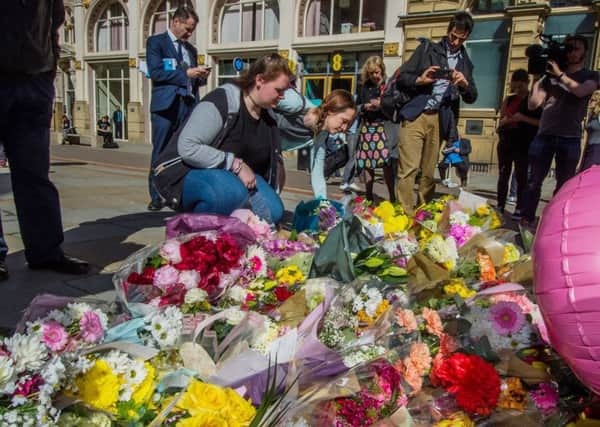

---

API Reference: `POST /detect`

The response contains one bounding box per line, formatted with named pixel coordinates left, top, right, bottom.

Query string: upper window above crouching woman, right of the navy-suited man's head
left=220, top=0, right=279, bottom=43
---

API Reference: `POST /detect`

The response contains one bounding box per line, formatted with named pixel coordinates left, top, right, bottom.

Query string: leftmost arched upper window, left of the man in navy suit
left=96, top=2, right=129, bottom=52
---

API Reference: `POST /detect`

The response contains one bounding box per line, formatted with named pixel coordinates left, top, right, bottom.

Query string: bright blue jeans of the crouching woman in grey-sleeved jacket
left=182, top=169, right=283, bottom=224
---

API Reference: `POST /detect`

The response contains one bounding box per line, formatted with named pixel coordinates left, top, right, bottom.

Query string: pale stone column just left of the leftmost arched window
left=72, top=3, right=93, bottom=136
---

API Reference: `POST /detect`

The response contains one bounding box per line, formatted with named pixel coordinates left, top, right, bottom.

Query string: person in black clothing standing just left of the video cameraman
left=496, top=69, right=542, bottom=219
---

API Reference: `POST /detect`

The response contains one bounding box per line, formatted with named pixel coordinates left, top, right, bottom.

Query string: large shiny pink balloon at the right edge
left=533, top=166, right=600, bottom=394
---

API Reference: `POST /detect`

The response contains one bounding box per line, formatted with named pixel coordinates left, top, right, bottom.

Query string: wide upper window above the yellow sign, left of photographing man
left=304, top=0, right=385, bottom=37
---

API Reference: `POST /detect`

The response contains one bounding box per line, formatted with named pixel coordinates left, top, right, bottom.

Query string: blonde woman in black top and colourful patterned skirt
left=356, top=56, right=396, bottom=203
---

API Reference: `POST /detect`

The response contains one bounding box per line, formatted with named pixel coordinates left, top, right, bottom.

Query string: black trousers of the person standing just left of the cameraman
left=496, top=137, right=529, bottom=210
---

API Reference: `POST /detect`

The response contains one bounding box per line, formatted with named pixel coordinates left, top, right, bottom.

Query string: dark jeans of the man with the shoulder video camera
left=522, top=135, right=581, bottom=221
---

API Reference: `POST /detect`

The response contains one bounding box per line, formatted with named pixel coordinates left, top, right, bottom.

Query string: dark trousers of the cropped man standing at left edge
left=0, top=72, right=63, bottom=263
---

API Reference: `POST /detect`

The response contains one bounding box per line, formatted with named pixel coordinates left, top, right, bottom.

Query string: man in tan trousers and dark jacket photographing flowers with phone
left=397, top=11, right=477, bottom=212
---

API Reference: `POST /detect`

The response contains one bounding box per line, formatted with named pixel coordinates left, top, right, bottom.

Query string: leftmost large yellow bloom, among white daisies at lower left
left=75, top=360, right=122, bottom=412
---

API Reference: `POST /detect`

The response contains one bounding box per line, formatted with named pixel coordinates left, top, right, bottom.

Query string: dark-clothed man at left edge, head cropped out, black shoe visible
left=0, top=0, right=89, bottom=279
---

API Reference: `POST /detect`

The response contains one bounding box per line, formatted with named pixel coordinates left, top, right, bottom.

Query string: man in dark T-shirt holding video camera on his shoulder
left=521, top=35, right=598, bottom=225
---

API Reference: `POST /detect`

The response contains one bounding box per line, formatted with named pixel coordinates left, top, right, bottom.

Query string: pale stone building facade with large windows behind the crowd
left=54, top=0, right=600, bottom=164
